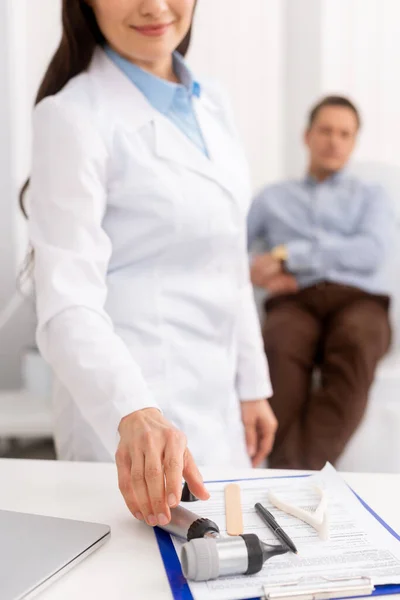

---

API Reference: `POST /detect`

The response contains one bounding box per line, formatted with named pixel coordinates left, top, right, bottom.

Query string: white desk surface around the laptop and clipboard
left=0, top=459, right=400, bottom=600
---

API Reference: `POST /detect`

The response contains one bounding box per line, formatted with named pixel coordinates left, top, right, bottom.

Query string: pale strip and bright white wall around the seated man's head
left=284, top=0, right=400, bottom=176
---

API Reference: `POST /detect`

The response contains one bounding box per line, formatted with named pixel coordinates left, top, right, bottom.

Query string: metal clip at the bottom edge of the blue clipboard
left=262, top=576, right=375, bottom=600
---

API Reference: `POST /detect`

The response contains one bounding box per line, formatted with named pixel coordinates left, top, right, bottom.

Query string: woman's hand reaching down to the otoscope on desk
left=115, top=408, right=210, bottom=526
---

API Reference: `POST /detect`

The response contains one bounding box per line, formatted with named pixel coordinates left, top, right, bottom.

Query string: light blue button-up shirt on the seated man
left=248, top=172, right=394, bottom=294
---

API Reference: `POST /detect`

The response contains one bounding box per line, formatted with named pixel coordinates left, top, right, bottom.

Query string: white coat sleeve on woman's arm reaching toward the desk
left=29, top=98, right=156, bottom=455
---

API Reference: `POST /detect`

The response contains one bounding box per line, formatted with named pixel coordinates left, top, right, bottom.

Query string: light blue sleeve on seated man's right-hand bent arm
left=287, top=186, right=394, bottom=275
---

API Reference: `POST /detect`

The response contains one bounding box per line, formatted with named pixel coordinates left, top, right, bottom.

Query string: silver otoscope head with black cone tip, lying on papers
left=181, top=534, right=289, bottom=581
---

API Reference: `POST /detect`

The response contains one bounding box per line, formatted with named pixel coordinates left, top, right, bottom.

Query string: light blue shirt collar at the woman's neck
left=104, top=45, right=201, bottom=114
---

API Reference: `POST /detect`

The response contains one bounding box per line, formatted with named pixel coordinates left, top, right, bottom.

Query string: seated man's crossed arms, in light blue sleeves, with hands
left=248, top=186, right=393, bottom=294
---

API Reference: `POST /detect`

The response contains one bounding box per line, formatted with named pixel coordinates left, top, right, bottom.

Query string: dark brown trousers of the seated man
left=263, top=283, right=391, bottom=469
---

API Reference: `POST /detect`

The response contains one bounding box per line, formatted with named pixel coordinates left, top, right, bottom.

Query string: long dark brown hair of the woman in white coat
left=19, top=0, right=197, bottom=217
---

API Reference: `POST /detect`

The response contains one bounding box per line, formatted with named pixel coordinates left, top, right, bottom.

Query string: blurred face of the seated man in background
left=305, top=106, right=358, bottom=174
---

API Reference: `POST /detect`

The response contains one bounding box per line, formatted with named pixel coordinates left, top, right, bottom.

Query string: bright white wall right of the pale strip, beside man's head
left=321, top=0, right=400, bottom=166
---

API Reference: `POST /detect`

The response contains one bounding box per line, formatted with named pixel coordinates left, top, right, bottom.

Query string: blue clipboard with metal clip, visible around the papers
left=154, top=474, right=400, bottom=600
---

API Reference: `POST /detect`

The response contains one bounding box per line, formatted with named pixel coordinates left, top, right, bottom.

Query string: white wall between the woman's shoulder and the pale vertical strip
left=189, top=0, right=284, bottom=187
